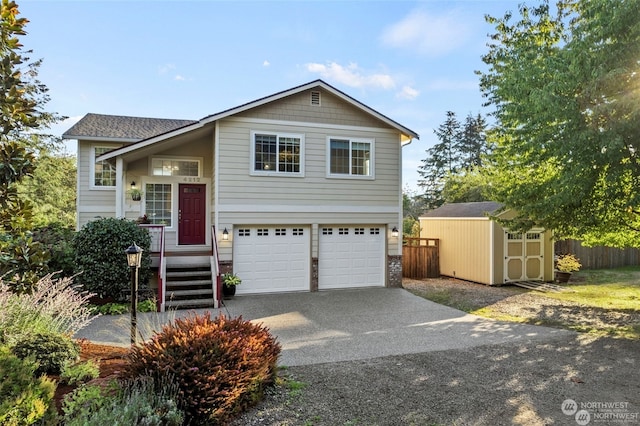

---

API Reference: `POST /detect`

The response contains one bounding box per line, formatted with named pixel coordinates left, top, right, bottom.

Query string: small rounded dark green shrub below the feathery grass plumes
left=11, top=333, right=80, bottom=374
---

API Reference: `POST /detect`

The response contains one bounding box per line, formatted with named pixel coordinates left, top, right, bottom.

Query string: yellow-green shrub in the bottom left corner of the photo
left=0, top=346, right=57, bottom=426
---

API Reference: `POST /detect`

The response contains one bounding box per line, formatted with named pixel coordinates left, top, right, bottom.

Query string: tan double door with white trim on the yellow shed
left=504, top=230, right=544, bottom=282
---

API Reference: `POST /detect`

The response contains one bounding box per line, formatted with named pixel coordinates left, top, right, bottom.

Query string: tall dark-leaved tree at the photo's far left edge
left=0, top=0, right=60, bottom=291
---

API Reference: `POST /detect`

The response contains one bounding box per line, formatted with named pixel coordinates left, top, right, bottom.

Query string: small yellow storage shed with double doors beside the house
left=419, top=201, right=553, bottom=285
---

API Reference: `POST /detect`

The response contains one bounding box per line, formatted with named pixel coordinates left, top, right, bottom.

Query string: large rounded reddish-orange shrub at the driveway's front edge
left=125, top=313, right=280, bottom=424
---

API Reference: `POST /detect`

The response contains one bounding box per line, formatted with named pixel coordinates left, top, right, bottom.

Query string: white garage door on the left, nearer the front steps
left=233, top=226, right=311, bottom=294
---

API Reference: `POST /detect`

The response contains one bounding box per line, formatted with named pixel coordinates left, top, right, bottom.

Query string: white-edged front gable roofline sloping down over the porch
left=81, top=80, right=420, bottom=161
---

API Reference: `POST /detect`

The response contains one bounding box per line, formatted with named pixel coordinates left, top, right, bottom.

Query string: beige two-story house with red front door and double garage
left=63, top=80, right=418, bottom=306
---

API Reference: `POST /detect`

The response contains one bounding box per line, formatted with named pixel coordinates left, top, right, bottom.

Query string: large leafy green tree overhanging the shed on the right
left=479, top=0, right=640, bottom=247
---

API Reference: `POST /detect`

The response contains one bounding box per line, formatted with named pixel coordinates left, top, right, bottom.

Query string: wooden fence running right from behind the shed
left=555, top=240, right=640, bottom=269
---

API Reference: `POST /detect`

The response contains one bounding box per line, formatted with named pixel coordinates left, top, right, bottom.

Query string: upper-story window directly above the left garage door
left=251, top=132, right=304, bottom=176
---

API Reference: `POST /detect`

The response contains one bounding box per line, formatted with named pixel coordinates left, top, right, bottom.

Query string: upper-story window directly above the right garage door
left=328, top=138, right=373, bottom=178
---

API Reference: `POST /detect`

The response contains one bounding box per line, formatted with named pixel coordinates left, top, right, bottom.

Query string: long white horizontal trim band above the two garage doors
left=216, top=204, right=398, bottom=215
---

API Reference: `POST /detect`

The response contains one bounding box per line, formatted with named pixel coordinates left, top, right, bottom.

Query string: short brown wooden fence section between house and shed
left=402, top=238, right=440, bottom=279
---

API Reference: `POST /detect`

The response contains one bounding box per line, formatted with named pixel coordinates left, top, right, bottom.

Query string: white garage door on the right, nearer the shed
left=318, top=226, right=386, bottom=290
